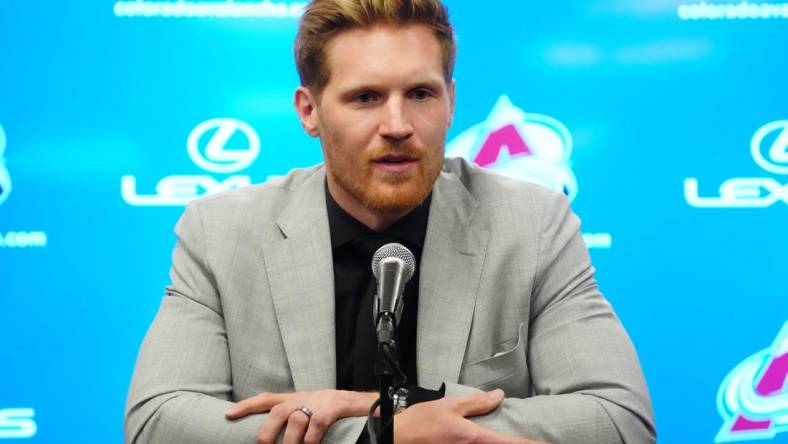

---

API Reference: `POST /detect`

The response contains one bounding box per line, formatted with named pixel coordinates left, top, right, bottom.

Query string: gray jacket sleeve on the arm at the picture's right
left=447, top=194, right=656, bottom=444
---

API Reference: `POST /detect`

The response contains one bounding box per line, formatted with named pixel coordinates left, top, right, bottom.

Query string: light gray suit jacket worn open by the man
left=125, top=159, right=655, bottom=444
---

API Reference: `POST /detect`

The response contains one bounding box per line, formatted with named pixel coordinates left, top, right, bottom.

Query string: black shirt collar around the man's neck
left=325, top=180, right=432, bottom=249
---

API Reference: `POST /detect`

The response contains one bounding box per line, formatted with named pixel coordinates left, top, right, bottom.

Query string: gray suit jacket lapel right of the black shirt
left=417, top=173, right=489, bottom=388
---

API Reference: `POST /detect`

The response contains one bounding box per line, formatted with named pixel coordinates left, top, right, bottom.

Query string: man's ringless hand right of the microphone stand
left=394, top=389, right=548, bottom=444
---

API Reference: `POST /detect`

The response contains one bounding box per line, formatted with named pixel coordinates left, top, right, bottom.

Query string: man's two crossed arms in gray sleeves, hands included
left=125, top=194, right=655, bottom=444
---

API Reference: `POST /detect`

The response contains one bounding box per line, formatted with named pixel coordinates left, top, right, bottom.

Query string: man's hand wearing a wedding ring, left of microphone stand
left=225, top=390, right=378, bottom=444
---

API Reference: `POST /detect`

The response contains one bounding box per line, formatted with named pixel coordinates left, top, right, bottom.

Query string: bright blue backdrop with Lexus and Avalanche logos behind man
left=0, top=0, right=788, bottom=443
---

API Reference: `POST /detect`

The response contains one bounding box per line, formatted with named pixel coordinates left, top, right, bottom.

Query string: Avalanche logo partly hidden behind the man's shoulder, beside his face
left=446, top=95, right=577, bottom=199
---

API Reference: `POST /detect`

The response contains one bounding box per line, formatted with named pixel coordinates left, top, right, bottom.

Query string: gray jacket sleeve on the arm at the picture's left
left=124, top=205, right=366, bottom=444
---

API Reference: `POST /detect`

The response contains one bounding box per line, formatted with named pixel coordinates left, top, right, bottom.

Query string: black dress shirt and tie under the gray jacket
left=326, top=187, right=445, bottom=443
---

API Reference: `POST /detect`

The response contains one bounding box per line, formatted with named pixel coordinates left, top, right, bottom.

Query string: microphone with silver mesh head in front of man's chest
left=372, top=243, right=416, bottom=344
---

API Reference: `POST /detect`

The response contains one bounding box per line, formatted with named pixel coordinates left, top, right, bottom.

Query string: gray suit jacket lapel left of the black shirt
left=263, top=168, right=336, bottom=391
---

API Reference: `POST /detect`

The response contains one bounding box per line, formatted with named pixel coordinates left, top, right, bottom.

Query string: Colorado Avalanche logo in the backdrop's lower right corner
left=716, top=322, right=788, bottom=442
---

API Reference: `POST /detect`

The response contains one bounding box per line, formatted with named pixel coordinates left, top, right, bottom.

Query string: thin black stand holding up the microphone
left=375, top=311, right=402, bottom=444
